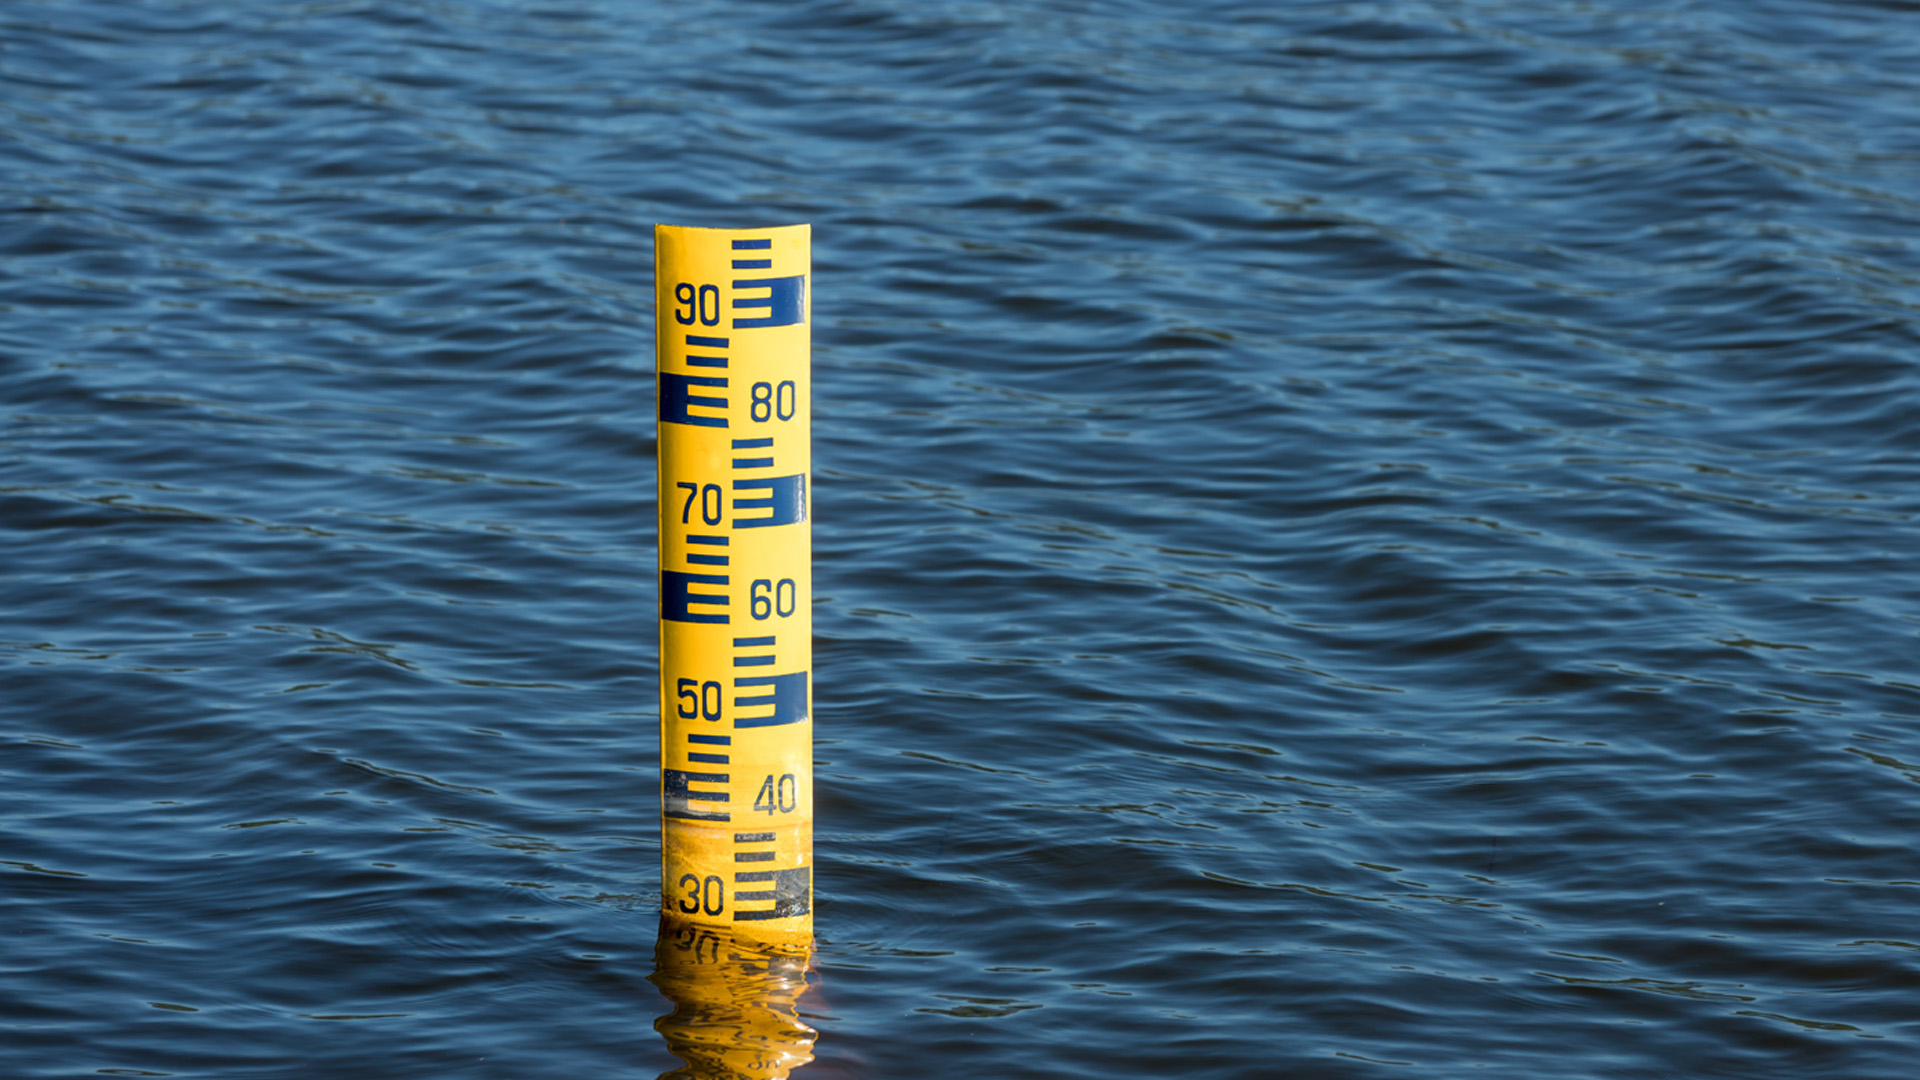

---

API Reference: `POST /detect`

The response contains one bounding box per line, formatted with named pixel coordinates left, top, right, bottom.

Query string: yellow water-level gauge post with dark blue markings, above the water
left=653, top=225, right=814, bottom=947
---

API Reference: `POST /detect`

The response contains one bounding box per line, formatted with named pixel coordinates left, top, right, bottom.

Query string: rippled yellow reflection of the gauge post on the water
left=649, top=920, right=818, bottom=1080
